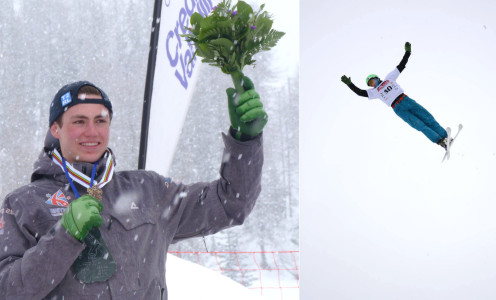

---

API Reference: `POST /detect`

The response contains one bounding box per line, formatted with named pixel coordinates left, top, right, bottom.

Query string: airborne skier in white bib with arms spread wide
left=341, top=42, right=448, bottom=149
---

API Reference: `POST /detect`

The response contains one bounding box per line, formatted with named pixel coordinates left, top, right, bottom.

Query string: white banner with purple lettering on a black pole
left=145, top=0, right=213, bottom=176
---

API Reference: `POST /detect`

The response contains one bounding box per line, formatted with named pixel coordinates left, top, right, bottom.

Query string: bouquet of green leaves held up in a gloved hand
left=183, top=0, right=284, bottom=91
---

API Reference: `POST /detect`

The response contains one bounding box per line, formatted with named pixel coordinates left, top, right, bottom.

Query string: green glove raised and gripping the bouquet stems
left=226, top=76, right=268, bottom=140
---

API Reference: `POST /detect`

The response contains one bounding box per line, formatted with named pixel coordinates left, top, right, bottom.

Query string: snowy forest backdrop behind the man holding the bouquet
left=0, top=0, right=299, bottom=299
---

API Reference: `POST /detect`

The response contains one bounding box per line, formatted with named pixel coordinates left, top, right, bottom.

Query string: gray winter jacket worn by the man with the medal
left=0, top=135, right=263, bottom=300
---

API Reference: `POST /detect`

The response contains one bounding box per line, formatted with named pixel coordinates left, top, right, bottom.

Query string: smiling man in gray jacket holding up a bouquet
left=0, top=78, right=267, bottom=300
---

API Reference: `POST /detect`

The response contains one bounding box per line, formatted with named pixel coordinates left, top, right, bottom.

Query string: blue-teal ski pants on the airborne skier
left=393, top=96, right=448, bottom=143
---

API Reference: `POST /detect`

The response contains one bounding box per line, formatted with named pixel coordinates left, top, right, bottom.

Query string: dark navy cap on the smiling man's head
left=48, top=81, right=112, bottom=126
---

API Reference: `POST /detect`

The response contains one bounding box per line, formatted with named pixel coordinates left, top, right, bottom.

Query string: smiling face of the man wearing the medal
left=50, top=95, right=110, bottom=163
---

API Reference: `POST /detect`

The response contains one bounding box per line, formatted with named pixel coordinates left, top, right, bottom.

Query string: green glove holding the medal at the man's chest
left=62, top=195, right=103, bottom=242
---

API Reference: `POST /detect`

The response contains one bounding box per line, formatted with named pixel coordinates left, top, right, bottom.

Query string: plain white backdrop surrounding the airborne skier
left=300, top=0, right=496, bottom=300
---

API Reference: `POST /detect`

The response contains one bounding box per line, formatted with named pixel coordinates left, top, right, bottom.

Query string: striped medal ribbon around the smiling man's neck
left=52, top=149, right=114, bottom=198
